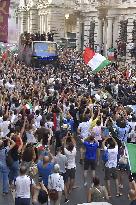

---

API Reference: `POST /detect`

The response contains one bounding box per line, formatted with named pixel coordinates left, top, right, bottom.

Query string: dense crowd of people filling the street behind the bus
left=0, top=49, right=136, bottom=205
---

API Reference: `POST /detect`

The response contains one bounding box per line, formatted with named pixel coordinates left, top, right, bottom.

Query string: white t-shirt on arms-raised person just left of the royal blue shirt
left=64, top=147, right=76, bottom=169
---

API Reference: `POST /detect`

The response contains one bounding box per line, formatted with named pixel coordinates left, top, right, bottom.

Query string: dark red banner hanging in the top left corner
left=0, top=0, right=10, bottom=43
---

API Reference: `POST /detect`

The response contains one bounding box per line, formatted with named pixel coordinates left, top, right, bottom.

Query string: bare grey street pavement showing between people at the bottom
left=0, top=149, right=130, bottom=205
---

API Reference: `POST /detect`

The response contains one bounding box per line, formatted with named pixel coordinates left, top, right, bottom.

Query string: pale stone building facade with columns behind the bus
left=18, top=0, right=136, bottom=53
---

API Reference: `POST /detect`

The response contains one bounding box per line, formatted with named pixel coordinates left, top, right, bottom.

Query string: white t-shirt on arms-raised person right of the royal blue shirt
left=104, top=145, right=118, bottom=168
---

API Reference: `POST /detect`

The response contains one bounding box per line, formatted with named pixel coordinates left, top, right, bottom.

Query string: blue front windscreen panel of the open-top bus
left=32, top=41, right=57, bottom=58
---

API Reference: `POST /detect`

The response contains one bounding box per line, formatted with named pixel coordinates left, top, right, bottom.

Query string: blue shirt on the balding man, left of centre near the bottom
left=37, top=161, right=54, bottom=187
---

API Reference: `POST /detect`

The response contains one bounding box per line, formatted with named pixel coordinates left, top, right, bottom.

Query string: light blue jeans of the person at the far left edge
left=0, top=164, right=9, bottom=193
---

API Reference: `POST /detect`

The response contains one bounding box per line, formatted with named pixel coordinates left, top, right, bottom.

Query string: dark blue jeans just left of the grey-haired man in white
left=9, top=161, right=19, bottom=183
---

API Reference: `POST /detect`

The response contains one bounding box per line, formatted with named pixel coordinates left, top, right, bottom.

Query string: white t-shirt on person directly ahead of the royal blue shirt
left=78, top=121, right=91, bottom=138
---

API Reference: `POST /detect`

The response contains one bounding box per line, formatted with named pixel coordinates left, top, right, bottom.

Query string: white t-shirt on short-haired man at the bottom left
left=15, top=175, right=34, bottom=199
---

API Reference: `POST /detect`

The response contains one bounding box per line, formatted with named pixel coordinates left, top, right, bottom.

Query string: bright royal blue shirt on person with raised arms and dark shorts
left=84, top=141, right=98, bottom=160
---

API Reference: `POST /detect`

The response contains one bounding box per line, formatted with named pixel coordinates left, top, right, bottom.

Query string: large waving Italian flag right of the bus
left=83, top=48, right=111, bottom=73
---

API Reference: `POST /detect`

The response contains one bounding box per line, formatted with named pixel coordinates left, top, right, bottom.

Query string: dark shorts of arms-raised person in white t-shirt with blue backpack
left=105, top=167, right=118, bottom=180
